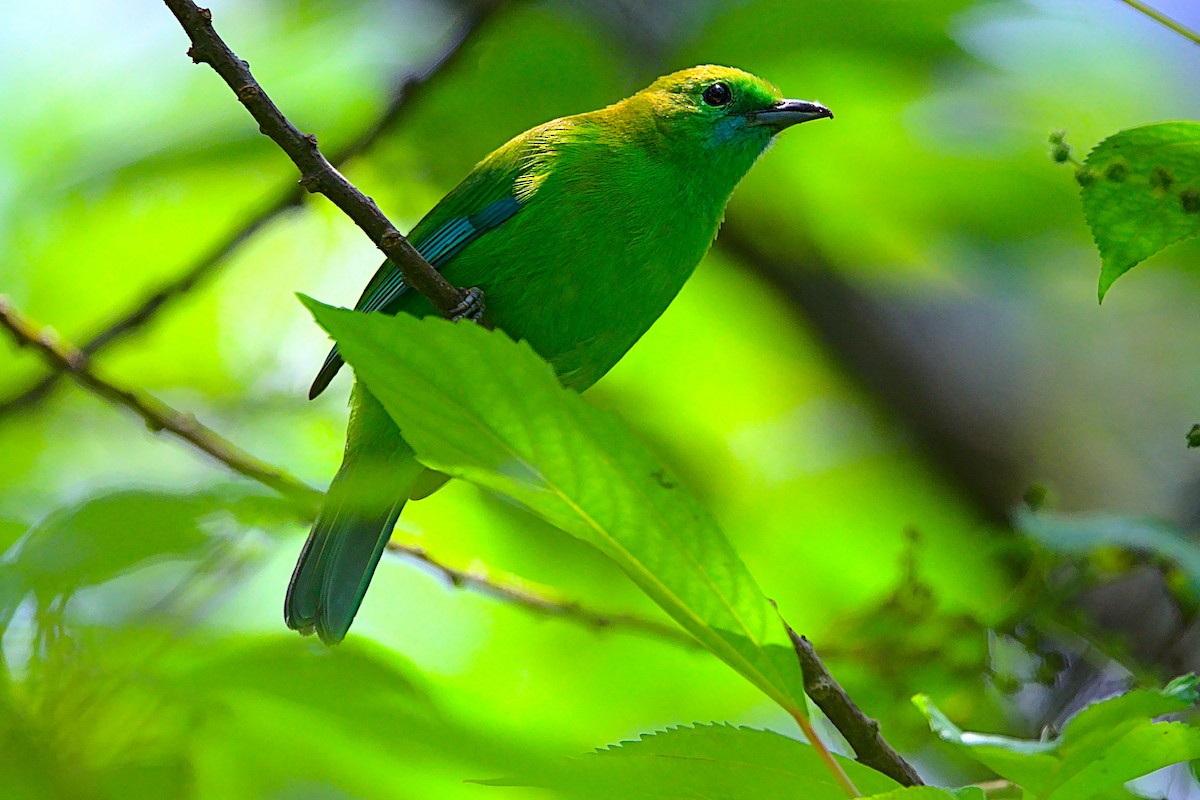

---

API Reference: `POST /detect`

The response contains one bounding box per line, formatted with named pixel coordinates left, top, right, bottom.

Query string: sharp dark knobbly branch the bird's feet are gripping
left=163, top=0, right=464, bottom=317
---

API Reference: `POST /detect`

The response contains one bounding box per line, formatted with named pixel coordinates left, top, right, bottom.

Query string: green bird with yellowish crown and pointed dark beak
left=284, top=66, right=833, bottom=644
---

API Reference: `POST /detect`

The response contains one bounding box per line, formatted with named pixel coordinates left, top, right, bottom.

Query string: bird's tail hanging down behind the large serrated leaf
left=283, top=390, right=425, bottom=644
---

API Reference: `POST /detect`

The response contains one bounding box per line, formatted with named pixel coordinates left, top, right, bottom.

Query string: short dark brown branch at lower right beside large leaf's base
left=784, top=622, right=924, bottom=786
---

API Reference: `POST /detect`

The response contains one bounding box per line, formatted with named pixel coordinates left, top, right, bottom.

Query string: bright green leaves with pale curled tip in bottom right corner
left=913, top=675, right=1200, bottom=800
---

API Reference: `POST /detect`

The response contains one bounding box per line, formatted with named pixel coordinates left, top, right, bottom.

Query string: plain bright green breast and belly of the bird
left=446, top=145, right=727, bottom=390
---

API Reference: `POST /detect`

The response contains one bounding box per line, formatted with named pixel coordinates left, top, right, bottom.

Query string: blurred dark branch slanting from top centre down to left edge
left=0, top=0, right=505, bottom=417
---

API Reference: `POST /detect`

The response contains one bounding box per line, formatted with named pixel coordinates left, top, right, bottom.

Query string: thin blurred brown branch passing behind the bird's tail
left=0, top=295, right=698, bottom=646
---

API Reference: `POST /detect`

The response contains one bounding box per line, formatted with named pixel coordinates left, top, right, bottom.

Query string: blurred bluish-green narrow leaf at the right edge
left=1013, top=509, right=1200, bottom=595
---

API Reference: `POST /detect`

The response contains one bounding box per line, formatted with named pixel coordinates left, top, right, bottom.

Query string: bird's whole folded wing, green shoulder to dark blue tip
left=308, top=124, right=556, bottom=398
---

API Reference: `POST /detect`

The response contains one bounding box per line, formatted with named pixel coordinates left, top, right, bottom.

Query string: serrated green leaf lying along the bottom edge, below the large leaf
left=481, top=724, right=902, bottom=800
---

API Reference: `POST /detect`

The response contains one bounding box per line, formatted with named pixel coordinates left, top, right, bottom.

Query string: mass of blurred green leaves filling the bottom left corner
left=0, top=487, right=537, bottom=800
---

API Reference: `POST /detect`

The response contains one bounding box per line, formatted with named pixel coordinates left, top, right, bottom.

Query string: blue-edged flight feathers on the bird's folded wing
left=308, top=196, right=521, bottom=399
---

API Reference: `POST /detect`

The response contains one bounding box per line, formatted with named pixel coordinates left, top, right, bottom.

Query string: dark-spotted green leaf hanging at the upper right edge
left=1079, top=122, right=1200, bottom=301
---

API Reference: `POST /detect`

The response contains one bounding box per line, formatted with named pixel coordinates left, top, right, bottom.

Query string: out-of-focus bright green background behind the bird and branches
left=7, top=0, right=1200, bottom=798
